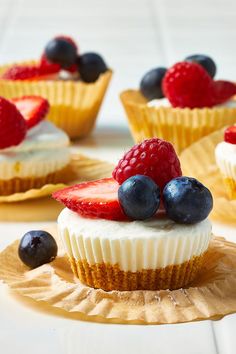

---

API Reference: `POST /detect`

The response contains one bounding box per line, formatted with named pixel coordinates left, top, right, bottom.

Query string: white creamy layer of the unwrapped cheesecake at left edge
left=0, top=121, right=70, bottom=180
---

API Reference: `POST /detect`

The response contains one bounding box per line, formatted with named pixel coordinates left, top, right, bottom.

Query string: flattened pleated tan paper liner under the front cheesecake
left=0, top=228, right=236, bottom=324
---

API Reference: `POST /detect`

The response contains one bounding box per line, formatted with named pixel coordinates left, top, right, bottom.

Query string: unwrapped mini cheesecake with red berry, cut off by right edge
left=215, top=125, right=236, bottom=199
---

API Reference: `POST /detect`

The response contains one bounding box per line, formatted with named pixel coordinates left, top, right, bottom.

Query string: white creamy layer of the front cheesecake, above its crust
left=58, top=208, right=211, bottom=272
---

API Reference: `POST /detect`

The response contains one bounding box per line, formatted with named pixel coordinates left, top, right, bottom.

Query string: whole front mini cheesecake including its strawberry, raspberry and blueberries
left=53, top=138, right=212, bottom=291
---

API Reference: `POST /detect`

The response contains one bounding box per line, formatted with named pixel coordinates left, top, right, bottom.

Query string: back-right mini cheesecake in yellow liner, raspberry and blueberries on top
left=121, top=55, right=236, bottom=153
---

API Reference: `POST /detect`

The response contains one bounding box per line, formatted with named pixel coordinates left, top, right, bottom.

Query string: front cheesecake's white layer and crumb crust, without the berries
left=58, top=208, right=211, bottom=291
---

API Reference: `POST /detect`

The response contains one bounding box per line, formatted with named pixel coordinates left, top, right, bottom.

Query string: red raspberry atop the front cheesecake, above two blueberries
left=112, top=138, right=182, bottom=190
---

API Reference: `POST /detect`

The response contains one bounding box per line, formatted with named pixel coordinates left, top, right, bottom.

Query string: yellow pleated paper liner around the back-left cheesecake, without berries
left=0, top=61, right=112, bottom=138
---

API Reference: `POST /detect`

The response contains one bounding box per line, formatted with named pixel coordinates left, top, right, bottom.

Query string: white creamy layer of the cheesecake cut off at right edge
left=215, top=141, right=236, bottom=181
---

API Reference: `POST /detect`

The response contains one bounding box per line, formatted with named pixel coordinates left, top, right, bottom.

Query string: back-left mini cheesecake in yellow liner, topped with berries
left=0, top=36, right=112, bottom=138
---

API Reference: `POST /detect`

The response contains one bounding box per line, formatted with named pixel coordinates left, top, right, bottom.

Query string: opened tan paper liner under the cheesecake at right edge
left=180, top=128, right=236, bottom=223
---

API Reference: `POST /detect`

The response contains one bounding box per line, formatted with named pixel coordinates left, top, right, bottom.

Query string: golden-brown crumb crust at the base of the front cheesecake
left=70, top=253, right=205, bottom=291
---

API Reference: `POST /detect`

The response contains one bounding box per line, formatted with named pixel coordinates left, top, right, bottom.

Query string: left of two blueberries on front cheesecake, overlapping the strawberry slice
left=118, top=175, right=160, bottom=220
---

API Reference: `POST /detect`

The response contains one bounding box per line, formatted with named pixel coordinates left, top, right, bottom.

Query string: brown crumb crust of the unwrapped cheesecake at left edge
left=0, top=166, right=68, bottom=196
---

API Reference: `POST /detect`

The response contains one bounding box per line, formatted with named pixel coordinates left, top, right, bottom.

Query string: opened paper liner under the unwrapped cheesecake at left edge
left=0, top=154, right=114, bottom=221
